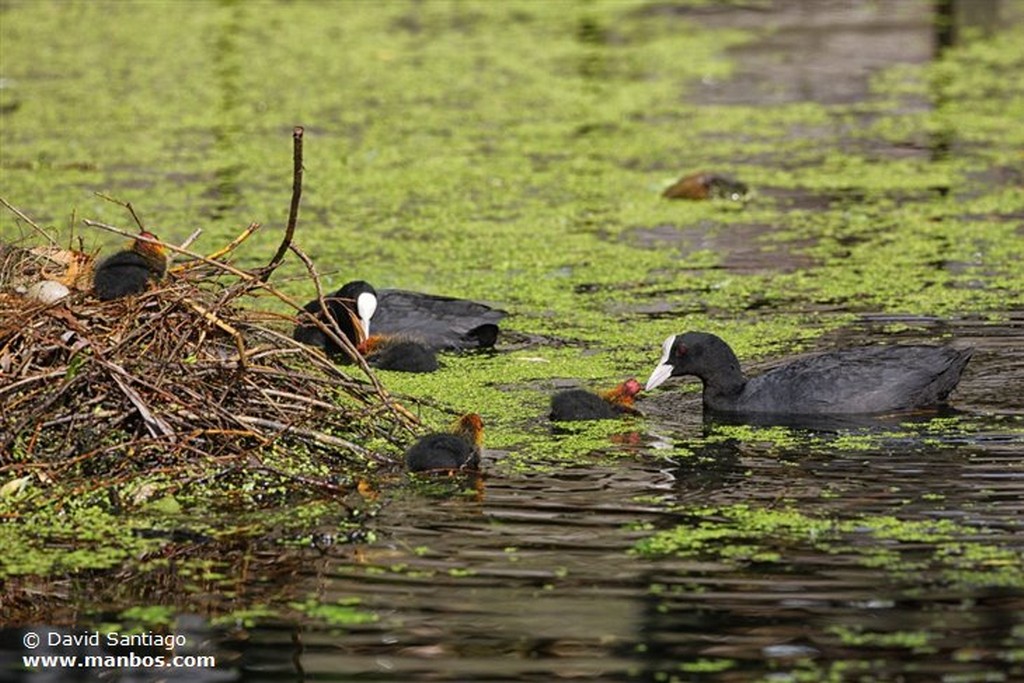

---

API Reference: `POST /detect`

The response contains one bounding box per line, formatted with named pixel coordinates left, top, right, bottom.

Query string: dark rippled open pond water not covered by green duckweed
left=0, top=2, right=1024, bottom=682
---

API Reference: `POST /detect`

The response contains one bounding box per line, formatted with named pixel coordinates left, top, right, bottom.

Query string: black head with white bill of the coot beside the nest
left=292, top=280, right=377, bottom=356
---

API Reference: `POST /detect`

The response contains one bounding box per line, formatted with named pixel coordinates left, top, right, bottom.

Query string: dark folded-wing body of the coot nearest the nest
left=373, top=290, right=508, bottom=349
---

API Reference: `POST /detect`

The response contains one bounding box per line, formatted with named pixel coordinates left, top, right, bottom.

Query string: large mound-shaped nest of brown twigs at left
left=0, top=226, right=416, bottom=499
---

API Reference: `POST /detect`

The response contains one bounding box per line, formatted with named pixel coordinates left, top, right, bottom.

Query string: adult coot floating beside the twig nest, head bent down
left=294, top=281, right=507, bottom=354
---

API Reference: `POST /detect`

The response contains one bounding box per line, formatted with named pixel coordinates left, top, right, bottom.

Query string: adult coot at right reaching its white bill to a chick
left=646, top=332, right=973, bottom=415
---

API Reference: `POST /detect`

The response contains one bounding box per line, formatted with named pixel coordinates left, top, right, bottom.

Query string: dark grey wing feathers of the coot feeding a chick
left=735, top=346, right=971, bottom=415
